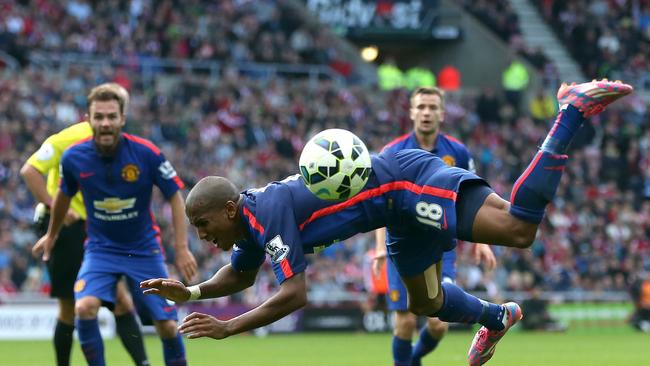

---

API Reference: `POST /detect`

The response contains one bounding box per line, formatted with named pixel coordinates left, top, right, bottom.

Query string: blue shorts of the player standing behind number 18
left=386, top=251, right=456, bottom=311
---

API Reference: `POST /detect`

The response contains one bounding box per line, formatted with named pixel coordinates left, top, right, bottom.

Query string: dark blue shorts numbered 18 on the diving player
left=380, top=150, right=484, bottom=277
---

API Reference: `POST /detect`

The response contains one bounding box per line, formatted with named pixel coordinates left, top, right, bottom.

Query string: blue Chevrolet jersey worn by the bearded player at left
left=60, top=133, right=183, bottom=255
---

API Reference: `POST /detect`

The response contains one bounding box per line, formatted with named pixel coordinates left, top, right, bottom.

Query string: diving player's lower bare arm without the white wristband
left=178, top=272, right=307, bottom=339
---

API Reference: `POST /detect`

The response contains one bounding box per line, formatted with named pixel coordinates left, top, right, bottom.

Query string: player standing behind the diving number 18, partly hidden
left=373, top=87, right=496, bottom=366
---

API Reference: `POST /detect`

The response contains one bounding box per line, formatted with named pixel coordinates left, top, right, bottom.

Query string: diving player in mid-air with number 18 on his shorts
left=140, top=80, right=632, bottom=366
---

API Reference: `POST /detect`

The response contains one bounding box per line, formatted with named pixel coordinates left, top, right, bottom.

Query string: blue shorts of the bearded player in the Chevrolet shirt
left=74, top=251, right=178, bottom=320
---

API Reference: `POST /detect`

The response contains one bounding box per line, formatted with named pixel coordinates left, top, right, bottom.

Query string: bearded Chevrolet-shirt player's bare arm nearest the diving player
left=169, top=191, right=197, bottom=281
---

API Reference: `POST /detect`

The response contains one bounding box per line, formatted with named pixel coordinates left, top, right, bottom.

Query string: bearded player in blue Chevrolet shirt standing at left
left=37, top=85, right=196, bottom=365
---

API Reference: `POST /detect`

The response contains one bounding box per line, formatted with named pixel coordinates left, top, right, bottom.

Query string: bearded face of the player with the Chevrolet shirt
left=89, top=100, right=126, bottom=152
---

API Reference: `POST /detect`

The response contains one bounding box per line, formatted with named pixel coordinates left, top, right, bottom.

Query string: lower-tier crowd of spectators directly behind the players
left=0, top=63, right=650, bottom=301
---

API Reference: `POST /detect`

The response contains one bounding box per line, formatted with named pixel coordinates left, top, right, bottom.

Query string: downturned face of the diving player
left=187, top=201, right=240, bottom=251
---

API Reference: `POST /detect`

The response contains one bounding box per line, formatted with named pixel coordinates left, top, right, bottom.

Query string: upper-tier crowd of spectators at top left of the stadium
left=0, top=0, right=336, bottom=64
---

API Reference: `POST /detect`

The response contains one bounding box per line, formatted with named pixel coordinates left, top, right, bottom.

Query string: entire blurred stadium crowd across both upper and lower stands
left=0, top=0, right=650, bottom=303
